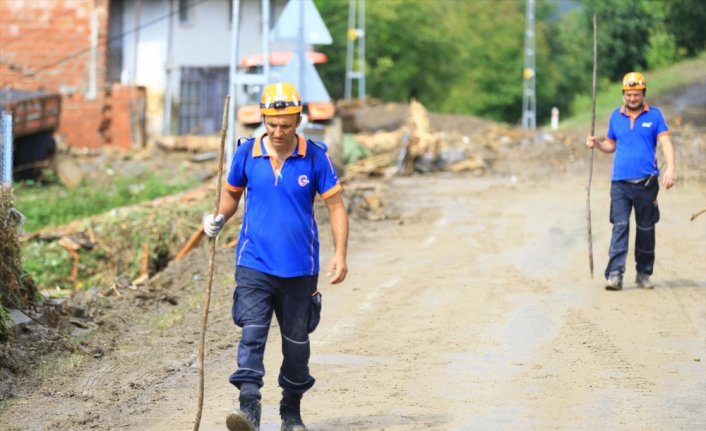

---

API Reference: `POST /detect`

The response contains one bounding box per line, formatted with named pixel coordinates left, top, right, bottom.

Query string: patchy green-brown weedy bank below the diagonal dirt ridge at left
left=17, top=203, right=212, bottom=295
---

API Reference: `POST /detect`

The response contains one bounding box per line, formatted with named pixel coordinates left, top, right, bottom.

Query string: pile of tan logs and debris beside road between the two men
left=346, top=100, right=576, bottom=178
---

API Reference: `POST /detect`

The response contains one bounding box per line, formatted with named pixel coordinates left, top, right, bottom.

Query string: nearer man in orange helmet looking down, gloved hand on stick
left=203, top=83, right=348, bottom=431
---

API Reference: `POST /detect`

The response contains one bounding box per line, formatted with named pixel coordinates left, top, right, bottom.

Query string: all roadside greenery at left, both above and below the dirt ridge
left=15, top=171, right=208, bottom=295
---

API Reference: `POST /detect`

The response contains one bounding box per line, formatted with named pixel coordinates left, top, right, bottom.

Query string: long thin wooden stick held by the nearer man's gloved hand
left=194, top=95, right=230, bottom=431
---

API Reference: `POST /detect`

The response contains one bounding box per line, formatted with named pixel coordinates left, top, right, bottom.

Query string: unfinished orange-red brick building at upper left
left=0, top=0, right=145, bottom=149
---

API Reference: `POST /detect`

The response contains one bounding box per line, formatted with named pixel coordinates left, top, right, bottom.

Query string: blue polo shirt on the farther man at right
left=606, top=103, right=669, bottom=181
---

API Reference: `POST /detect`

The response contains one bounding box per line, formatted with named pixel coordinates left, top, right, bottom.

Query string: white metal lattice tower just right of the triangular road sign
left=344, top=0, right=365, bottom=100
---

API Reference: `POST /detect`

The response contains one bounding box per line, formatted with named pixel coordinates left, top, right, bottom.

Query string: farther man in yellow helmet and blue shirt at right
left=586, top=72, right=676, bottom=290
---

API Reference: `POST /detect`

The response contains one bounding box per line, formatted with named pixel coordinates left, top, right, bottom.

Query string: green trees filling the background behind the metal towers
left=316, top=0, right=706, bottom=123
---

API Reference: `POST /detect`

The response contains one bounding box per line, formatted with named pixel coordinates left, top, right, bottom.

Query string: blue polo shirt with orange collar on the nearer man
left=226, top=135, right=341, bottom=277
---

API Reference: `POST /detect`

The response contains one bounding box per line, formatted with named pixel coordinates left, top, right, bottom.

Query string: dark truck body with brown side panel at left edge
left=0, top=89, right=61, bottom=179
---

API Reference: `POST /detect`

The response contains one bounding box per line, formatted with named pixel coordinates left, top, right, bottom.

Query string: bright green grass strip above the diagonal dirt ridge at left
left=15, top=172, right=197, bottom=232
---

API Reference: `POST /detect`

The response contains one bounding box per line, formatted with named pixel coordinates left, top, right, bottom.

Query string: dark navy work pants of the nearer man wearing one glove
left=229, top=266, right=321, bottom=395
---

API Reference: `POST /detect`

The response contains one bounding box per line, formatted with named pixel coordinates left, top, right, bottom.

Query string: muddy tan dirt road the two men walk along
left=0, top=169, right=706, bottom=431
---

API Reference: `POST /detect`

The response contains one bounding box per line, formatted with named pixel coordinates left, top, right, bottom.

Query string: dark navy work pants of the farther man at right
left=605, top=178, right=659, bottom=278
